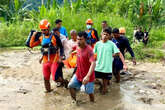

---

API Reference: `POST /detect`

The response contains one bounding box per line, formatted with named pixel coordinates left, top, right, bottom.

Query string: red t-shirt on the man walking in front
left=76, top=45, right=95, bottom=82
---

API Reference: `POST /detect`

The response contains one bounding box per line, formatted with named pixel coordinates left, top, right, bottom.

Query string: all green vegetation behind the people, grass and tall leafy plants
left=0, top=0, right=165, bottom=59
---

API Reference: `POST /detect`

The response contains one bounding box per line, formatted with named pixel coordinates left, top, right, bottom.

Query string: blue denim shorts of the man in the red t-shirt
left=68, top=74, right=94, bottom=94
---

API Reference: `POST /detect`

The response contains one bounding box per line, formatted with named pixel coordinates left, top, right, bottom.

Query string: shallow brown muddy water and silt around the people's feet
left=0, top=50, right=165, bottom=110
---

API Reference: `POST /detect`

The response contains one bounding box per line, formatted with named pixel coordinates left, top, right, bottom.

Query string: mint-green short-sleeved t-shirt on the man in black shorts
left=94, top=40, right=120, bottom=73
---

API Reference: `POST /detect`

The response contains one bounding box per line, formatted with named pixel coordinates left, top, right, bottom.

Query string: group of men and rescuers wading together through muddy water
left=30, top=19, right=136, bottom=102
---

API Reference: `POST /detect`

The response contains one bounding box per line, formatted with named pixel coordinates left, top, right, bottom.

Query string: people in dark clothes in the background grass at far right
left=133, top=27, right=149, bottom=45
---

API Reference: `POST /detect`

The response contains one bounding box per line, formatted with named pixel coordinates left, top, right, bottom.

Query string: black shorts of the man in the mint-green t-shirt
left=95, top=71, right=112, bottom=80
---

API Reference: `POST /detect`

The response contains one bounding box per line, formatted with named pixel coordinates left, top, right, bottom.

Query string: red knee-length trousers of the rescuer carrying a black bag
left=43, top=62, right=62, bottom=81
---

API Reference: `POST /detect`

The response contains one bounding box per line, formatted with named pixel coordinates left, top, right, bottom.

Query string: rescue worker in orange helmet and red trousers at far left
left=30, top=19, right=67, bottom=92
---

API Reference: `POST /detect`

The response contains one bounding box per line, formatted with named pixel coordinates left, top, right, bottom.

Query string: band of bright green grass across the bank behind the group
left=0, top=3, right=165, bottom=61
